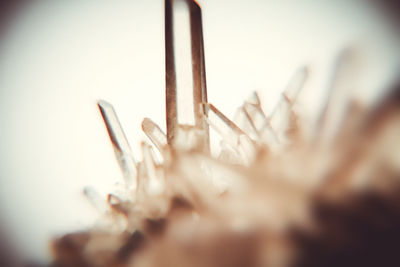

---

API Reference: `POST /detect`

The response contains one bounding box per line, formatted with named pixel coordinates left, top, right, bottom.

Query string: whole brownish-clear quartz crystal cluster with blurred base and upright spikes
left=53, top=0, right=400, bottom=267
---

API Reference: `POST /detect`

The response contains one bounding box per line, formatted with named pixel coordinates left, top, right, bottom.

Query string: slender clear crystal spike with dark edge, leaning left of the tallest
left=98, top=100, right=137, bottom=190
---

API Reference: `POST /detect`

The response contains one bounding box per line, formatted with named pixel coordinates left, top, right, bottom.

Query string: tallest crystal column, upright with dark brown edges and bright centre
left=165, top=0, right=209, bottom=152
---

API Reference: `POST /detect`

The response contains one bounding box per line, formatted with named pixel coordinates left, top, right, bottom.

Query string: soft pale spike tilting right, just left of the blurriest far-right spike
left=269, top=67, right=309, bottom=141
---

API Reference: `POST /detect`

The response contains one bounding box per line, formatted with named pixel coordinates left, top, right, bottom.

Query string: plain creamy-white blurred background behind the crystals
left=0, top=0, right=400, bottom=262
